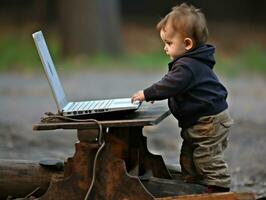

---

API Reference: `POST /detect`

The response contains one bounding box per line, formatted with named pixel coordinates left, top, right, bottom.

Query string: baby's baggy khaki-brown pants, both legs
left=180, top=110, right=233, bottom=188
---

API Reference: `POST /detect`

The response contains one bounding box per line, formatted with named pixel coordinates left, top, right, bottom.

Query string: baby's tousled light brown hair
left=156, top=3, right=209, bottom=47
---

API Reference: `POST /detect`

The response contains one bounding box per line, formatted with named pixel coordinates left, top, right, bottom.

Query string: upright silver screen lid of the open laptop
left=32, top=31, right=67, bottom=111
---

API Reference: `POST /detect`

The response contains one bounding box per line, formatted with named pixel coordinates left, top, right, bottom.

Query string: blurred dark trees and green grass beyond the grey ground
left=0, top=0, right=266, bottom=73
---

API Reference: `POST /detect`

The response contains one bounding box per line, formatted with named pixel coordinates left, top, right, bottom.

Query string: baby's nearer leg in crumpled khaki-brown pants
left=187, top=111, right=232, bottom=188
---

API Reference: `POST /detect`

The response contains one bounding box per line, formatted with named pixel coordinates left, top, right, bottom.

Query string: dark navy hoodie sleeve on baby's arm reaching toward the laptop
left=144, top=63, right=194, bottom=101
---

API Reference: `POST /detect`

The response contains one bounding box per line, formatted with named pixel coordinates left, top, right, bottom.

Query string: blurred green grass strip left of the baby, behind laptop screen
left=0, top=34, right=168, bottom=72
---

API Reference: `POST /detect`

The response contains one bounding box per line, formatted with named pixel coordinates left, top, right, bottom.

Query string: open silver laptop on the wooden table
left=32, top=31, right=141, bottom=117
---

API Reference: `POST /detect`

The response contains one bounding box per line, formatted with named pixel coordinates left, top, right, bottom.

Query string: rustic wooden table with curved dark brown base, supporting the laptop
left=33, top=103, right=253, bottom=200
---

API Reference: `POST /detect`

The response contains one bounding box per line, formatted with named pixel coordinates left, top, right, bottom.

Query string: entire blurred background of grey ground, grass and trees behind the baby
left=0, top=0, right=266, bottom=197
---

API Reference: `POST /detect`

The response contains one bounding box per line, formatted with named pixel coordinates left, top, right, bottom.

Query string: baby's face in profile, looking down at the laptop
left=160, top=25, right=187, bottom=60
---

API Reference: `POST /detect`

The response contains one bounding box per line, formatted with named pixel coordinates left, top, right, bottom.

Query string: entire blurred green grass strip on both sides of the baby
left=0, top=34, right=266, bottom=76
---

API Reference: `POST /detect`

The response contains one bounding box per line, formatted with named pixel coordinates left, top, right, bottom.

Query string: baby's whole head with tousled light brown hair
left=157, top=3, right=208, bottom=60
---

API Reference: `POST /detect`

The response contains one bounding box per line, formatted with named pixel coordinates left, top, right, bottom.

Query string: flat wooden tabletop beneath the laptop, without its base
left=33, top=102, right=170, bottom=130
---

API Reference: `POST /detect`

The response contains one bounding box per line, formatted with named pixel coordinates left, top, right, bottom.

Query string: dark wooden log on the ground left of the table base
left=0, top=159, right=62, bottom=199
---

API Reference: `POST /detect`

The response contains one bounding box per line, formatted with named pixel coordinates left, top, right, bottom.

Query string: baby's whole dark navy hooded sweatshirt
left=144, top=44, right=228, bottom=128
